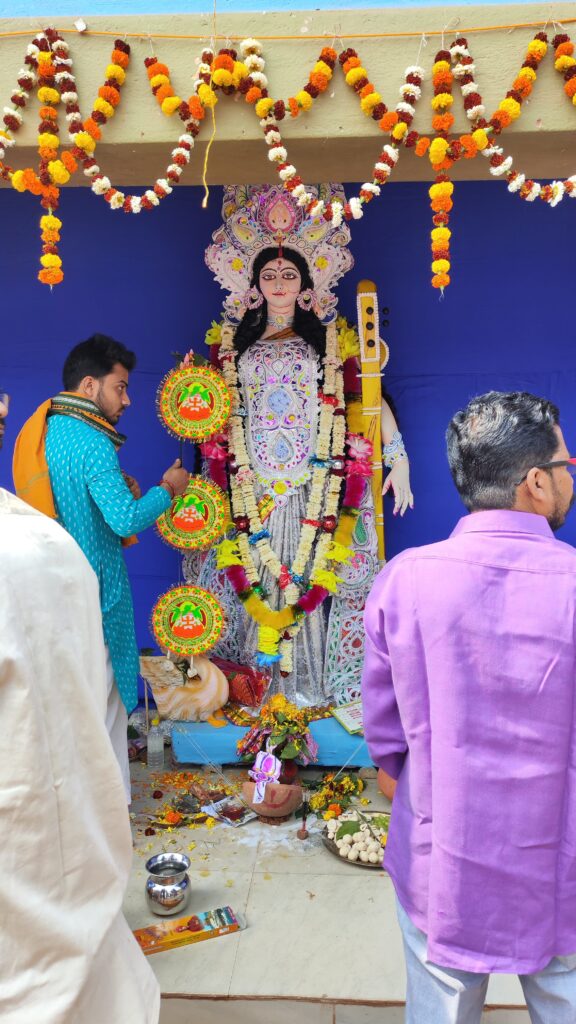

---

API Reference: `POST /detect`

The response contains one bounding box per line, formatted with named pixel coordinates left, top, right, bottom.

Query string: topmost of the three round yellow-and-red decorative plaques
left=158, top=366, right=231, bottom=441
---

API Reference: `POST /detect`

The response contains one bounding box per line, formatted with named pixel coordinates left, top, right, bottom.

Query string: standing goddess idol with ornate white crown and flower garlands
left=184, top=186, right=412, bottom=707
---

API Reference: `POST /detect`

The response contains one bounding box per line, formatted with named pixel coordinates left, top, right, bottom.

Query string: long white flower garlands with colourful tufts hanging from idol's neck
left=216, top=325, right=371, bottom=676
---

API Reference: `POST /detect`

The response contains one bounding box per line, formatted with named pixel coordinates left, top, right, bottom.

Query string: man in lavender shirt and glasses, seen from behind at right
left=363, top=391, right=576, bottom=1024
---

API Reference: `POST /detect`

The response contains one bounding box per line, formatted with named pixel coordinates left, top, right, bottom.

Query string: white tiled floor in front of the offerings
left=125, top=766, right=528, bottom=1024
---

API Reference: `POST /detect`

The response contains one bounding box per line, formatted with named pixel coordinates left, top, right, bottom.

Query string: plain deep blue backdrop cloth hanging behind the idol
left=0, top=181, right=576, bottom=704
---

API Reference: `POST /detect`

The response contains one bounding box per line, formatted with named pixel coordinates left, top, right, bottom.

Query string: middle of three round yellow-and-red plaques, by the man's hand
left=156, top=476, right=227, bottom=551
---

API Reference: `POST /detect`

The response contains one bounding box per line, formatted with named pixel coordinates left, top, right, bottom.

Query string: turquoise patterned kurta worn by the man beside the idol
left=46, top=415, right=170, bottom=712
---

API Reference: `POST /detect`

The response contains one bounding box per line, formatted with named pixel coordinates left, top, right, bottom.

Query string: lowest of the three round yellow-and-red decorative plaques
left=152, top=587, right=224, bottom=657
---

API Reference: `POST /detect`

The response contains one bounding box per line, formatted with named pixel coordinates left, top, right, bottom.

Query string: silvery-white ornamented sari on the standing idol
left=184, top=335, right=378, bottom=706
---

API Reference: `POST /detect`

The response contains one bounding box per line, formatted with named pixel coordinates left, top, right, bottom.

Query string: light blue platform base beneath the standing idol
left=172, top=718, right=372, bottom=768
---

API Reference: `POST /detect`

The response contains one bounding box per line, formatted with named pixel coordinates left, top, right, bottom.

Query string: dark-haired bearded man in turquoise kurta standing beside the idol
left=34, top=335, right=190, bottom=801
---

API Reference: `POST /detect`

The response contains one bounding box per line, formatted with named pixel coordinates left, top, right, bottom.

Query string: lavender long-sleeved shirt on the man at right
left=363, top=511, right=576, bottom=974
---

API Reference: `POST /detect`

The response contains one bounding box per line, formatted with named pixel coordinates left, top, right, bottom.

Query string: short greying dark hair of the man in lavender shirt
left=446, top=391, right=560, bottom=512
